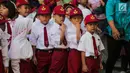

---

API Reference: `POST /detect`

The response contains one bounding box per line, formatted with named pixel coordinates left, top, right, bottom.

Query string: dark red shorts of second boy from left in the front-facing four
left=49, top=50, right=68, bottom=73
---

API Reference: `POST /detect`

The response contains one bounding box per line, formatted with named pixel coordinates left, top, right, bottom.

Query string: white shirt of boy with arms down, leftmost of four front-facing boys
left=29, top=19, right=53, bottom=49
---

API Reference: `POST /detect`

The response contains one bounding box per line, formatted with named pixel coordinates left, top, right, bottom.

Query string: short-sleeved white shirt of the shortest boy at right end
left=78, top=31, right=105, bottom=57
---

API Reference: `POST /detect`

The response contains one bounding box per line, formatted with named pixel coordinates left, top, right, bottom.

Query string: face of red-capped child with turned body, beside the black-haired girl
left=18, top=5, right=30, bottom=17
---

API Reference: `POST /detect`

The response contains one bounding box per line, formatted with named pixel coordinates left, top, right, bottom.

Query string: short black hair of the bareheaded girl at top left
left=0, top=1, right=16, bottom=19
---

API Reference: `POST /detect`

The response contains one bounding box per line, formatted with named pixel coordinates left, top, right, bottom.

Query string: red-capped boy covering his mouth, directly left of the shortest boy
left=65, top=7, right=83, bottom=73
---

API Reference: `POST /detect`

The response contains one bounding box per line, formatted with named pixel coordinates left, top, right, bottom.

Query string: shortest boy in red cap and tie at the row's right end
left=78, top=14, right=104, bottom=73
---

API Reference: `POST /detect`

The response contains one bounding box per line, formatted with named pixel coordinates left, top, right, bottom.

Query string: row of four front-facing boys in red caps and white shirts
left=30, top=5, right=104, bottom=73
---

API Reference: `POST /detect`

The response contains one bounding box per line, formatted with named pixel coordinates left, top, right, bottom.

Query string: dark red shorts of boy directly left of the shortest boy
left=68, top=49, right=82, bottom=73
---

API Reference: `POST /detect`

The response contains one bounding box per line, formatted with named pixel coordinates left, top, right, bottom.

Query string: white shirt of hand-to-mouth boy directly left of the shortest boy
left=65, top=23, right=78, bottom=49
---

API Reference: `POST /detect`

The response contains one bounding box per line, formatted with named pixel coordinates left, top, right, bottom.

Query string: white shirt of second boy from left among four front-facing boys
left=50, top=22, right=67, bottom=48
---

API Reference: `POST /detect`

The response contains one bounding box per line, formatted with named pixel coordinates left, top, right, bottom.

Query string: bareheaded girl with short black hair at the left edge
left=0, top=0, right=16, bottom=73
